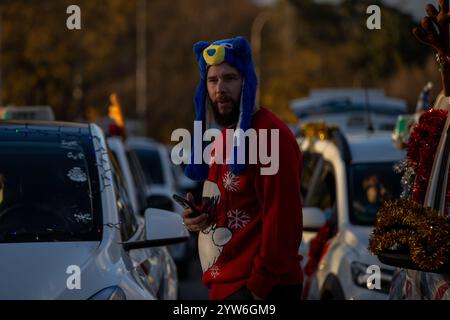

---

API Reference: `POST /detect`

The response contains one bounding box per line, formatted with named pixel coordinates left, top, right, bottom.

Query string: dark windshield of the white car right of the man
left=349, top=162, right=401, bottom=225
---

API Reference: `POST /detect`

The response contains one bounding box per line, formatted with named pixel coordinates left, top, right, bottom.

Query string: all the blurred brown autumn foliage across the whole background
left=0, top=0, right=436, bottom=142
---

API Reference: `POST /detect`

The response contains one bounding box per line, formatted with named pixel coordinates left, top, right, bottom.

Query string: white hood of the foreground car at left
left=0, top=242, right=100, bottom=300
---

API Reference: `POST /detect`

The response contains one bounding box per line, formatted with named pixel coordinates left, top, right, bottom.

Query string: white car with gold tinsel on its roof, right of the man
left=299, top=125, right=403, bottom=299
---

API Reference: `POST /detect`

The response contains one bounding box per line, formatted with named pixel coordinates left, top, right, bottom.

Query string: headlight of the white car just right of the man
left=350, top=261, right=394, bottom=293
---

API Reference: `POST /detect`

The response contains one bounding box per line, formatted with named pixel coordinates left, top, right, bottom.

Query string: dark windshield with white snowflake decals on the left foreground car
left=0, top=129, right=102, bottom=243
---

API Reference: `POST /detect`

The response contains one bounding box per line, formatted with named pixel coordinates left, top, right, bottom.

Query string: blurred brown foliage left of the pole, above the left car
left=0, top=0, right=134, bottom=120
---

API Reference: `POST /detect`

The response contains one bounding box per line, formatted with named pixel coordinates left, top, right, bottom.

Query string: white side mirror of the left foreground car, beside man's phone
left=123, top=208, right=189, bottom=251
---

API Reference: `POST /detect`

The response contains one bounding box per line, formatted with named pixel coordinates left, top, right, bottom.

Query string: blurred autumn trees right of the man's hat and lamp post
left=261, top=0, right=429, bottom=119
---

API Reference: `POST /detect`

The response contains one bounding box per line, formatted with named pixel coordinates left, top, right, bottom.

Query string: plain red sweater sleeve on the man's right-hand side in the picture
left=247, top=134, right=303, bottom=298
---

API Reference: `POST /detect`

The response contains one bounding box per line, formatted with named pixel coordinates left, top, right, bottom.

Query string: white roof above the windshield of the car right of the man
left=345, top=132, right=405, bottom=163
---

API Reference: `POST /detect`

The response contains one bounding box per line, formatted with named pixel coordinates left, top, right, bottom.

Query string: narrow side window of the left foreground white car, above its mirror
left=109, top=152, right=138, bottom=241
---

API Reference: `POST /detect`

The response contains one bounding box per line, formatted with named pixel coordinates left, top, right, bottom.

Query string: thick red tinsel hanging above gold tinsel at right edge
left=406, top=109, right=448, bottom=204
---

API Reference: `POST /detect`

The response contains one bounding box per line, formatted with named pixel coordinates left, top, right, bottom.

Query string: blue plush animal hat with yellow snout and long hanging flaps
left=185, top=37, right=258, bottom=181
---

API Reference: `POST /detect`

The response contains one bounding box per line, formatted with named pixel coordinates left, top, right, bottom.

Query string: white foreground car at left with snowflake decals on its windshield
left=0, top=122, right=189, bottom=300
